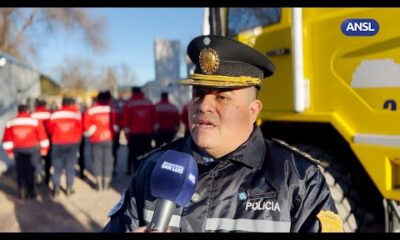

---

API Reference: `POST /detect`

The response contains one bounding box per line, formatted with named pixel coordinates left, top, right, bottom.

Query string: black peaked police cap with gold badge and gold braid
left=180, top=35, right=275, bottom=88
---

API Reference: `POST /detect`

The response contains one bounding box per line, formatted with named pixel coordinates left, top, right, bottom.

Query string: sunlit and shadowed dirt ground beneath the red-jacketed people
left=0, top=145, right=130, bottom=232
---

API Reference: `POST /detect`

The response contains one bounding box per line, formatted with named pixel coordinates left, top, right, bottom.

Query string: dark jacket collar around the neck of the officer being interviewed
left=185, top=124, right=267, bottom=168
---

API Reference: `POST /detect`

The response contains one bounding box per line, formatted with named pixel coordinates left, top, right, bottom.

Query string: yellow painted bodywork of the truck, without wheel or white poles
left=234, top=8, right=400, bottom=199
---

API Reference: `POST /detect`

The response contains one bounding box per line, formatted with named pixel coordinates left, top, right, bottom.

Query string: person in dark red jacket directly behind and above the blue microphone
left=123, top=87, right=155, bottom=175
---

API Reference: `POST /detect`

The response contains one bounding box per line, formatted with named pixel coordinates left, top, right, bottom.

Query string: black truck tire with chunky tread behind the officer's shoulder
left=294, top=144, right=383, bottom=232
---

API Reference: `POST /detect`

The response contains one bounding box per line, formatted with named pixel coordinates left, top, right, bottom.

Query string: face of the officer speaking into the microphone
left=189, top=86, right=262, bottom=158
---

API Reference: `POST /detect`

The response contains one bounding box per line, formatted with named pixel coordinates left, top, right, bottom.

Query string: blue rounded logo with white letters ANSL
left=341, top=18, right=379, bottom=36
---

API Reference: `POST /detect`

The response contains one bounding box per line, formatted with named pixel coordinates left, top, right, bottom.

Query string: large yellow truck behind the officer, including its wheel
left=203, top=8, right=400, bottom=232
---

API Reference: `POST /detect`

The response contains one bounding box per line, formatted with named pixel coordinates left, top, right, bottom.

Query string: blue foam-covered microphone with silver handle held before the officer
left=148, top=150, right=198, bottom=232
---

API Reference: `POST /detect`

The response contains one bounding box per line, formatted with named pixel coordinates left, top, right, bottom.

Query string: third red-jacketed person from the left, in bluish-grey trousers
left=49, top=97, right=82, bottom=197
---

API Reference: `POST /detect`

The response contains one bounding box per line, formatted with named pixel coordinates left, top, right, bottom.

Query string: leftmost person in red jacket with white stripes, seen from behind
left=3, top=104, right=49, bottom=200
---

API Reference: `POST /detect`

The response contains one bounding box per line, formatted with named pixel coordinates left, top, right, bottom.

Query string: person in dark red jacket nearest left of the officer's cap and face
left=154, top=92, right=179, bottom=147
